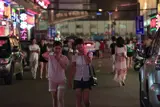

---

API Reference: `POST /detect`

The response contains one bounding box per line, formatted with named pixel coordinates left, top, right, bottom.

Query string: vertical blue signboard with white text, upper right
left=136, top=16, right=144, bottom=35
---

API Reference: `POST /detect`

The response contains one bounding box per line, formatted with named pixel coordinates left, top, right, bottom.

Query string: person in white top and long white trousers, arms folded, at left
left=29, top=39, right=40, bottom=79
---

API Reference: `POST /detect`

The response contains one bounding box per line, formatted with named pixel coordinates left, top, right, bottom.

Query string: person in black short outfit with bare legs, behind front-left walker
left=39, top=40, right=48, bottom=79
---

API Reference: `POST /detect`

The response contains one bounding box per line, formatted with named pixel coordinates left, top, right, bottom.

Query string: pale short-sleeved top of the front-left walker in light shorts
left=48, top=53, right=69, bottom=83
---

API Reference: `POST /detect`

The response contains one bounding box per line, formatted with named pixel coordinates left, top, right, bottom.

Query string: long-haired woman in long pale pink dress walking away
left=114, top=37, right=127, bottom=86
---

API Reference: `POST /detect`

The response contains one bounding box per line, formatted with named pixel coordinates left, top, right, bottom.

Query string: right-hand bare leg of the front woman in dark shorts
left=83, top=89, right=90, bottom=107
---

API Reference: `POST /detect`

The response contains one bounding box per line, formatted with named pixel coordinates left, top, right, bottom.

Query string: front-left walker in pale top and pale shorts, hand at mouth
left=42, top=41, right=69, bottom=107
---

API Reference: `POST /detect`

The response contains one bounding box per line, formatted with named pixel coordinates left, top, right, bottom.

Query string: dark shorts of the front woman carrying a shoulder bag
left=73, top=79, right=92, bottom=90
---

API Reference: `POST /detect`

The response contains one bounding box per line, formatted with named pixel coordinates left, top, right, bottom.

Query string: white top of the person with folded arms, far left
left=29, top=44, right=40, bottom=61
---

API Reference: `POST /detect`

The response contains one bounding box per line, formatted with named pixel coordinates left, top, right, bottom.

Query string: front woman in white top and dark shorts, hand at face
left=69, top=39, right=92, bottom=107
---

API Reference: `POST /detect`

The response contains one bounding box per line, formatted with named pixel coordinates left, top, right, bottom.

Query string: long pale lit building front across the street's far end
left=56, top=20, right=135, bottom=36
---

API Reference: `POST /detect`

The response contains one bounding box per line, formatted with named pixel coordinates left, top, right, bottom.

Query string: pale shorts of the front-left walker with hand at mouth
left=48, top=80, right=66, bottom=92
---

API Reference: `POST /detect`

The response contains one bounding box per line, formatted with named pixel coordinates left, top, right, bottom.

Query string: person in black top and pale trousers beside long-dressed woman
left=110, top=36, right=116, bottom=72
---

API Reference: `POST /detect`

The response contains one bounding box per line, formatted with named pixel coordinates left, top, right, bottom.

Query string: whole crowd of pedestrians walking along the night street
left=29, top=36, right=152, bottom=107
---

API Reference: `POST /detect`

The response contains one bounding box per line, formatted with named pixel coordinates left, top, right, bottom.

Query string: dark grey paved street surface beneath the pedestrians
left=0, top=54, right=139, bottom=107
